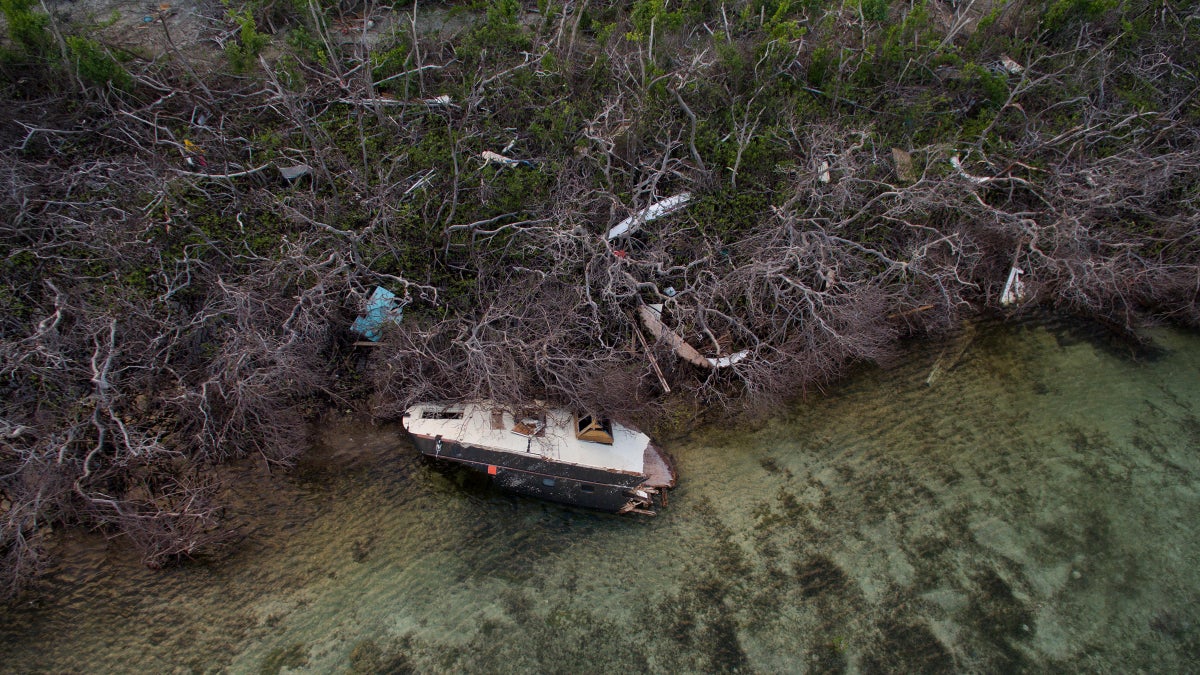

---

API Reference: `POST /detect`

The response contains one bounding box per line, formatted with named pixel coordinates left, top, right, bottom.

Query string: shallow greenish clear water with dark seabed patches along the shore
left=0, top=317, right=1200, bottom=673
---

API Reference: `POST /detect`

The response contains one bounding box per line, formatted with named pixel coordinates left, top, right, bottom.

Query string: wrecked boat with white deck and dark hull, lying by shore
left=403, top=404, right=676, bottom=515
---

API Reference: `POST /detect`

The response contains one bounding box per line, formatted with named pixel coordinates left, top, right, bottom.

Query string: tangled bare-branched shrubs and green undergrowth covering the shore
left=0, top=0, right=1200, bottom=592
